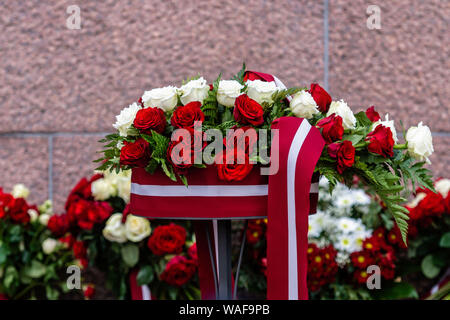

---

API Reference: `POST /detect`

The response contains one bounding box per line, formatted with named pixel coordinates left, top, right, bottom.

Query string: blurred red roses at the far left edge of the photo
left=0, top=188, right=33, bottom=224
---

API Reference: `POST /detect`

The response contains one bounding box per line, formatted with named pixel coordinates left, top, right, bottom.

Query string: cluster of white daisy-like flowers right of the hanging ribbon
left=308, top=178, right=372, bottom=266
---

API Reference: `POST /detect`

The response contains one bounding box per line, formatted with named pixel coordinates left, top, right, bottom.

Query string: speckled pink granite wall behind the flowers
left=0, top=0, right=450, bottom=210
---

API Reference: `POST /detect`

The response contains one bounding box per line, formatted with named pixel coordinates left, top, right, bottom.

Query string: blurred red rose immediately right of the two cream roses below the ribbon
left=147, top=223, right=186, bottom=256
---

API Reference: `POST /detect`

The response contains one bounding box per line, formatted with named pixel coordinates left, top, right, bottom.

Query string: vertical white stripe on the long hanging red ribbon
left=287, top=119, right=311, bottom=300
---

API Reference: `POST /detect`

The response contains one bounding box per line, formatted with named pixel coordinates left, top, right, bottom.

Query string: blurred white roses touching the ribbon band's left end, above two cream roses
left=91, top=170, right=131, bottom=203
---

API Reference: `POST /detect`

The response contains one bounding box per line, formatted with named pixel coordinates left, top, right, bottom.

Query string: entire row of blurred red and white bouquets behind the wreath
left=0, top=172, right=450, bottom=299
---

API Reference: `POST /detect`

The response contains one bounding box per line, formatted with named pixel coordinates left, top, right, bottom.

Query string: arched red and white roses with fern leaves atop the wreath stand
left=97, top=64, right=433, bottom=241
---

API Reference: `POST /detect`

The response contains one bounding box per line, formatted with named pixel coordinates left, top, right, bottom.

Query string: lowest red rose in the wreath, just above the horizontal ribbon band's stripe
left=216, top=148, right=253, bottom=181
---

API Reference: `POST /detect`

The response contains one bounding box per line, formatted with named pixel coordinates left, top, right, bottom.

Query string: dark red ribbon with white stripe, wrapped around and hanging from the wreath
left=130, top=72, right=325, bottom=300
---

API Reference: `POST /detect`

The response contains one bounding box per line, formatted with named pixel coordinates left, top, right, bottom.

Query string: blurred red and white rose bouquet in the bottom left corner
left=0, top=184, right=79, bottom=300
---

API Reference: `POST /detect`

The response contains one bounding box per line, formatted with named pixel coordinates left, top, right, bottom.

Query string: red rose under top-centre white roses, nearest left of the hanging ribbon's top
left=233, top=94, right=264, bottom=126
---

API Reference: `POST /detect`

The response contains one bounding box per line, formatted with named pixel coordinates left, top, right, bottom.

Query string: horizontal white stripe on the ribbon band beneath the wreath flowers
left=131, top=183, right=268, bottom=197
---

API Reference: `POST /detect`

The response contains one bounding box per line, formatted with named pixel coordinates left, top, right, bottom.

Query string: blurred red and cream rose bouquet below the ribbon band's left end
left=48, top=170, right=199, bottom=299
